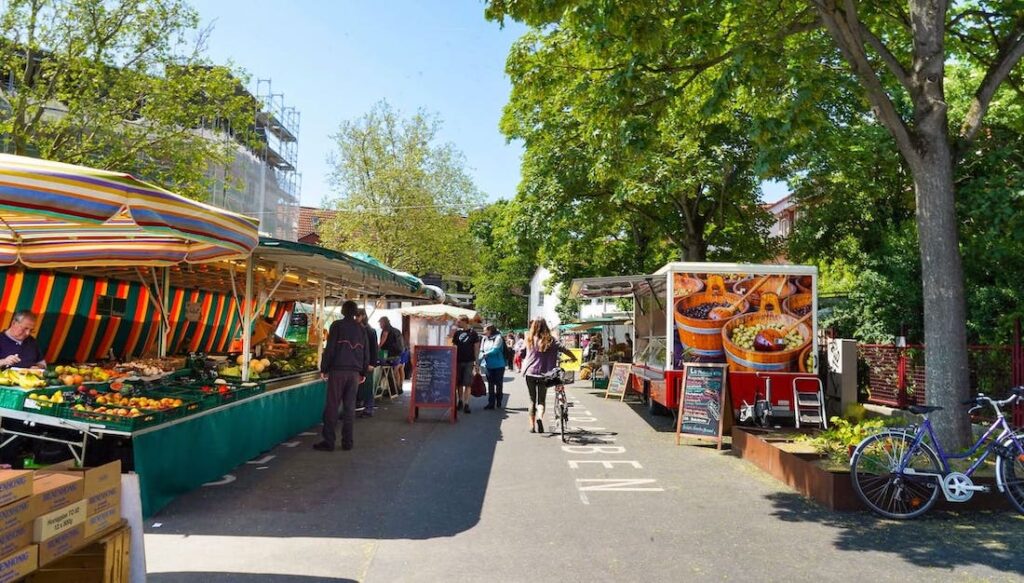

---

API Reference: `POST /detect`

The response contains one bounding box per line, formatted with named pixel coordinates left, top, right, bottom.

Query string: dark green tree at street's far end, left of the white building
left=469, top=201, right=537, bottom=329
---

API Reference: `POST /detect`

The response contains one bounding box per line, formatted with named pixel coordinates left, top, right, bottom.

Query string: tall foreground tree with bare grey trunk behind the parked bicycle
left=486, top=0, right=1024, bottom=445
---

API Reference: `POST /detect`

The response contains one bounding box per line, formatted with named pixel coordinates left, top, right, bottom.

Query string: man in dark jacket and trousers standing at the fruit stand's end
left=313, top=300, right=371, bottom=452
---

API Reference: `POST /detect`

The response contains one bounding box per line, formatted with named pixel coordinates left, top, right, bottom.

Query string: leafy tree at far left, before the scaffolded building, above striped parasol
left=0, top=0, right=255, bottom=200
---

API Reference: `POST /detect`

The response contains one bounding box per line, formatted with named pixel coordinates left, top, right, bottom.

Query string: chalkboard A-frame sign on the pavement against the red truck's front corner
left=676, top=363, right=732, bottom=449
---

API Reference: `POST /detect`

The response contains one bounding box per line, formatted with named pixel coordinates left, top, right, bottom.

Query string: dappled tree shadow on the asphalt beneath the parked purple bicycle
left=767, top=493, right=1024, bottom=576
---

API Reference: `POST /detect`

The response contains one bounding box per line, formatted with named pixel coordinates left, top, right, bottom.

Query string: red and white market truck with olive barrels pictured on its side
left=570, top=262, right=823, bottom=422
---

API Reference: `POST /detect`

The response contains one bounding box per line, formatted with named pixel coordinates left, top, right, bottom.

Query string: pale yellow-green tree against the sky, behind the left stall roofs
left=321, top=101, right=483, bottom=276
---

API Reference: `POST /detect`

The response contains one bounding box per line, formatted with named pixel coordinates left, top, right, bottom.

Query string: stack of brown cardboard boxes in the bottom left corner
left=0, top=461, right=121, bottom=583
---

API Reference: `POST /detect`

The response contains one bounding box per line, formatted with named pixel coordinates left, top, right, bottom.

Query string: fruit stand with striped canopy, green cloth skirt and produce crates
left=0, top=155, right=434, bottom=515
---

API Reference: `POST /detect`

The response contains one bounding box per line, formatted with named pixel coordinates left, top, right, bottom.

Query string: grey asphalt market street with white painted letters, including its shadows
left=145, top=370, right=1024, bottom=583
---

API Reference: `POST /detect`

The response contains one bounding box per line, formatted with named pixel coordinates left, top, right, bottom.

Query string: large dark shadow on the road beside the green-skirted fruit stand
left=146, top=391, right=508, bottom=540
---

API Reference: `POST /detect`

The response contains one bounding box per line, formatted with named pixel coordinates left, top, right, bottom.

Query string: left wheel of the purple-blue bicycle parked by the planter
left=850, top=431, right=942, bottom=519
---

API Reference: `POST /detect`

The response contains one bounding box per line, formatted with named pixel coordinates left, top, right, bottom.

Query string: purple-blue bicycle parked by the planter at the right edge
left=850, top=386, right=1024, bottom=519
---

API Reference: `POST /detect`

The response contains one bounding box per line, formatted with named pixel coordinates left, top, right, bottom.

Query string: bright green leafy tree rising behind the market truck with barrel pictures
left=502, top=27, right=772, bottom=261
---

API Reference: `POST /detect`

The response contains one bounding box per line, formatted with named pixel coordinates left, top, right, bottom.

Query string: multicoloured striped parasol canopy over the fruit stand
left=0, top=154, right=259, bottom=268
